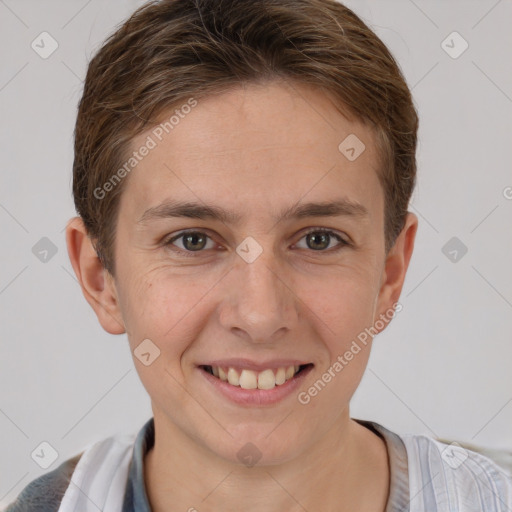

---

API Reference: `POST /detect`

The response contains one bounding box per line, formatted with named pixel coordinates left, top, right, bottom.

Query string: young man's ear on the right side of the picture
left=374, top=212, right=418, bottom=332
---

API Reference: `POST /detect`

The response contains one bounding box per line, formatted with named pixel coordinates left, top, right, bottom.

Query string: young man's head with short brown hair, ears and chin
left=67, top=0, right=418, bottom=463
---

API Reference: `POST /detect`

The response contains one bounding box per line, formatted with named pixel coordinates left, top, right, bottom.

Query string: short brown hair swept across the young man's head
left=73, top=0, right=418, bottom=275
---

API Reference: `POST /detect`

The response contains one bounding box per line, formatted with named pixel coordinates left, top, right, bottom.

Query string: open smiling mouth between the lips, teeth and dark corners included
left=199, top=363, right=313, bottom=390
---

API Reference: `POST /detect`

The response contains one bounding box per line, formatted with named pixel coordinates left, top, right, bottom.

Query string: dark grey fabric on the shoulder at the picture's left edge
left=4, top=452, right=83, bottom=512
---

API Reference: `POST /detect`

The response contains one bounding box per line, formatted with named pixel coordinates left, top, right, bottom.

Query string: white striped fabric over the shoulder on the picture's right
left=400, top=434, right=512, bottom=512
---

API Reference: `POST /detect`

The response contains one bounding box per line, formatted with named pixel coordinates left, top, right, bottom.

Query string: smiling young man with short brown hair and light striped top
left=7, top=0, right=512, bottom=512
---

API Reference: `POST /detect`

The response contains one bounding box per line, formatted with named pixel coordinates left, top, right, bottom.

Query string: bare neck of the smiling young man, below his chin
left=144, top=410, right=389, bottom=512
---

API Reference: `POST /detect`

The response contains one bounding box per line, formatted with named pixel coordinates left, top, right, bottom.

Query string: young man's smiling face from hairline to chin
left=89, top=79, right=408, bottom=464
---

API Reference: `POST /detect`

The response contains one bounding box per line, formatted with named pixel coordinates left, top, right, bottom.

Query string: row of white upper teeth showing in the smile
left=211, top=365, right=300, bottom=389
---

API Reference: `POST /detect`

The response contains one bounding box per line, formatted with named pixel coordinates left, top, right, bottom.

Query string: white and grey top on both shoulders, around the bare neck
left=5, top=418, right=512, bottom=512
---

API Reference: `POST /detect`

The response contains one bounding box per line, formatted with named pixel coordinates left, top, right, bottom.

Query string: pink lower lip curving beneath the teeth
left=197, top=366, right=313, bottom=406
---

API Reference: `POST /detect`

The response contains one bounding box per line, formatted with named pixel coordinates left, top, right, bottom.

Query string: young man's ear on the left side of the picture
left=66, top=217, right=126, bottom=334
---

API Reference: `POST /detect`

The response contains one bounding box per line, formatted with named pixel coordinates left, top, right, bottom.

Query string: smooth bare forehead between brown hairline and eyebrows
left=121, top=83, right=381, bottom=221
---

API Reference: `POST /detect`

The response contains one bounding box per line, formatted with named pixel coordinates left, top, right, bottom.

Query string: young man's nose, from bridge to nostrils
left=220, top=245, right=298, bottom=343
